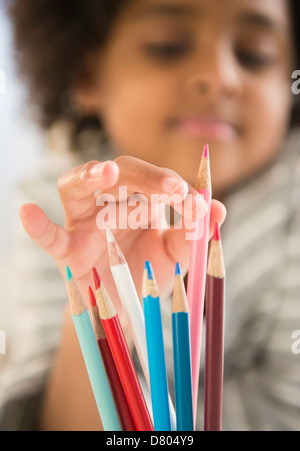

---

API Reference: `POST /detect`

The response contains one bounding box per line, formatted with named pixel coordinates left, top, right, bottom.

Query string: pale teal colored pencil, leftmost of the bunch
left=66, top=267, right=122, bottom=431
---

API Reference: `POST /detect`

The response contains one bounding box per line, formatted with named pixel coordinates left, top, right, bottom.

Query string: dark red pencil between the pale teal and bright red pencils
left=89, top=287, right=135, bottom=431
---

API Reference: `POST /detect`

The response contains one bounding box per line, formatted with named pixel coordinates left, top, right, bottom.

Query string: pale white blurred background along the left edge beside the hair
left=0, top=0, right=45, bottom=358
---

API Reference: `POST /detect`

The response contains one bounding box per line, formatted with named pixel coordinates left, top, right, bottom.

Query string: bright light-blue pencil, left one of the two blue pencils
left=142, top=262, right=171, bottom=431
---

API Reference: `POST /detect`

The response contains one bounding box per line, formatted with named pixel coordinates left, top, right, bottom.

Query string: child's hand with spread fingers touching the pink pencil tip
left=20, top=156, right=226, bottom=307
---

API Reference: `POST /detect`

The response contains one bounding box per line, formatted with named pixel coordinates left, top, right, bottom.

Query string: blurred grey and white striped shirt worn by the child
left=0, top=133, right=300, bottom=430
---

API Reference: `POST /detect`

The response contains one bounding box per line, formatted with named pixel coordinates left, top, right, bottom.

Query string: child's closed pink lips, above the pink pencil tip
left=171, top=117, right=238, bottom=141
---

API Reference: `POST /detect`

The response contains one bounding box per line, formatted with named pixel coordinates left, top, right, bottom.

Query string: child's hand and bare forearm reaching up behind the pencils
left=20, top=156, right=225, bottom=430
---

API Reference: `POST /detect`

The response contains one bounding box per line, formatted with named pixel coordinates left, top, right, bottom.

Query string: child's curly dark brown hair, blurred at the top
left=9, top=0, right=300, bottom=148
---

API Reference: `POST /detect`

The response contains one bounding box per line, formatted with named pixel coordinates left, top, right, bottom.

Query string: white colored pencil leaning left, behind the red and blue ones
left=106, top=228, right=176, bottom=431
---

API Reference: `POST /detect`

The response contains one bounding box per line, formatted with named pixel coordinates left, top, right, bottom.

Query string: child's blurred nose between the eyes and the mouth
left=186, top=42, right=242, bottom=98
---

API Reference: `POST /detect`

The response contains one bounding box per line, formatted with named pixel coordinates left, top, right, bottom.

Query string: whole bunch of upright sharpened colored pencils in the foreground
left=66, top=146, right=225, bottom=431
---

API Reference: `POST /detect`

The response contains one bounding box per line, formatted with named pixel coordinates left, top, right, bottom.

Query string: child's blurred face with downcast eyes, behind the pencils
left=78, top=0, right=293, bottom=196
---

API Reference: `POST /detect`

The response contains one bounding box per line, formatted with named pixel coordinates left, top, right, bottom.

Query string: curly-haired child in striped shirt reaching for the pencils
left=2, top=0, right=300, bottom=430
